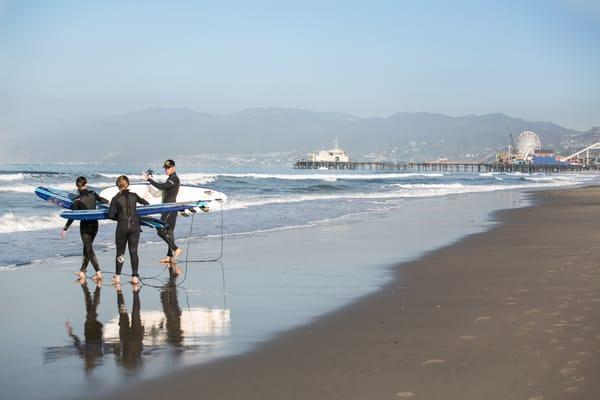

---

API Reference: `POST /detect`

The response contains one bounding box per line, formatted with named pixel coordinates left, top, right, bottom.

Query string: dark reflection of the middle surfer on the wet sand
left=116, top=285, right=144, bottom=370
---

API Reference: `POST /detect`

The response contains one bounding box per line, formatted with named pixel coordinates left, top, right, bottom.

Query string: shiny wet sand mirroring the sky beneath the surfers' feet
left=0, top=192, right=526, bottom=398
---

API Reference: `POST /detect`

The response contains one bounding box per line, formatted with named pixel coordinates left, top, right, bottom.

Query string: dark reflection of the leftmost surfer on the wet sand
left=65, top=283, right=103, bottom=373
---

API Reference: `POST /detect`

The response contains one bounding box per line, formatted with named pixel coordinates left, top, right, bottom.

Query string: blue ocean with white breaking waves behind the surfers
left=0, top=164, right=598, bottom=269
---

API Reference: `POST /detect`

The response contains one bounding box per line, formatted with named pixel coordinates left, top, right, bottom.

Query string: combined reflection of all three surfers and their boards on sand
left=44, top=270, right=231, bottom=374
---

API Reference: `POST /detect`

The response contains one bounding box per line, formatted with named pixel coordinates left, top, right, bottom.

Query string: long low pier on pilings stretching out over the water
left=294, top=160, right=598, bottom=173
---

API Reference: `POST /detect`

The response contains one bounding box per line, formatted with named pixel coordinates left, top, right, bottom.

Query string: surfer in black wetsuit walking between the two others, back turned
left=108, top=175, right=148, bottom=285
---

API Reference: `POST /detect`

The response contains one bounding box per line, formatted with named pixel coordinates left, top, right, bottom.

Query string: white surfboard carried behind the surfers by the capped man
left=100, top=183, right=227, bottom=211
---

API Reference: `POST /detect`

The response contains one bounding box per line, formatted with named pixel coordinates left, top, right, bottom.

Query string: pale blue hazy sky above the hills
left=0, top=0, right=600, bottom=130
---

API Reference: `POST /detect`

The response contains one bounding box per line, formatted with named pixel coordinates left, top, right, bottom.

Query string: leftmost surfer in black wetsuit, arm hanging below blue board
left=61, top=176, right=108, bottom=283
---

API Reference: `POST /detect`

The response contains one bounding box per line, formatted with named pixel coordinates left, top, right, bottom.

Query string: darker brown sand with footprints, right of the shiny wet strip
left=111, top=188, right=600, bottom=400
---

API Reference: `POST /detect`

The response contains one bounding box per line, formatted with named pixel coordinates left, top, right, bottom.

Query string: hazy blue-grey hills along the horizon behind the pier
left=19, top=108, right=584, bottom=162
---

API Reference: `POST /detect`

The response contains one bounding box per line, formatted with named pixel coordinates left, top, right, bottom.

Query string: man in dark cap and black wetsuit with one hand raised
left=144, top=159, right=182, bottom=263
